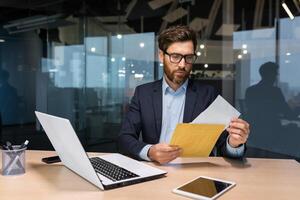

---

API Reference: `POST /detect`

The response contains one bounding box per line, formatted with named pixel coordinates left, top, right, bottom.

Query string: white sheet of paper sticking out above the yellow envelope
left=191, top=95, right=241, bottom=129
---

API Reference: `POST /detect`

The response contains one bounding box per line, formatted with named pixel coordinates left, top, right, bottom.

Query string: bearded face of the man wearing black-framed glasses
left=159, top=41, right=194, bottom=85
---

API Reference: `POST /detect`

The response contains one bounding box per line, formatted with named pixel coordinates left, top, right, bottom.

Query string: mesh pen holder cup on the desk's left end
left=2, top=145, right=27, bottom=176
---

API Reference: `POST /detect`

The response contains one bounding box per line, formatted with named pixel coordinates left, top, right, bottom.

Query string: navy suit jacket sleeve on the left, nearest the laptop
left=118, top=87, right=146, bottom=160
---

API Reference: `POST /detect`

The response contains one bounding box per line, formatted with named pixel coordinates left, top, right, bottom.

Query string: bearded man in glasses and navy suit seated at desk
left=118, top=26, right=249, bottom=164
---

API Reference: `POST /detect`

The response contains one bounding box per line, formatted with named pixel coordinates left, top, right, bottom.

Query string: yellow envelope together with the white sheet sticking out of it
left=170, top=95, right=240, bottom=157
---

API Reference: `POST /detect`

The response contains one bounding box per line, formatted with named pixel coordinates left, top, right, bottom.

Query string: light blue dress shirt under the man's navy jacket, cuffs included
left=139, top=78, right=245, bottom=161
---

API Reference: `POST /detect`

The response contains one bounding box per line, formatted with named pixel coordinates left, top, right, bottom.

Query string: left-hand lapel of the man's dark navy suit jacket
left=152, top=79, right=162, bottom=139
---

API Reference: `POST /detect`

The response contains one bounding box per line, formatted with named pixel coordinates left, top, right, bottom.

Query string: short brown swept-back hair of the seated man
left=158, top=25, right=197, bottom=52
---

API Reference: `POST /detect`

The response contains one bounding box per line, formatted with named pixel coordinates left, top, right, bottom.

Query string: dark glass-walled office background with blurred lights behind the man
left=0, top=0, right=300, bottom=159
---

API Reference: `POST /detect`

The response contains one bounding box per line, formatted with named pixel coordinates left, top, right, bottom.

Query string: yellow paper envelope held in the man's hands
left=170, top=123, right=225, bottom=157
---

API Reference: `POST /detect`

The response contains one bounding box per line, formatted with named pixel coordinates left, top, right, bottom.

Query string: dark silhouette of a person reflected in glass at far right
left=245, top=62, right=298, bottom=152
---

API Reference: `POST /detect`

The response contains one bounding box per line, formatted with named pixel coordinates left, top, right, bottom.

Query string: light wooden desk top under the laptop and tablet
left=0, top=151, right=300, bottom=200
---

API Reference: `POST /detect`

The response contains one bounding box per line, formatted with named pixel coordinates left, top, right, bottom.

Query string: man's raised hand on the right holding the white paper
left=226, top=118, right=250, bottom=148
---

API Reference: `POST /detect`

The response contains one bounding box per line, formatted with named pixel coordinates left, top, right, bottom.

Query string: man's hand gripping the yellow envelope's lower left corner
left=148, top=143, right=182, bottom=164
